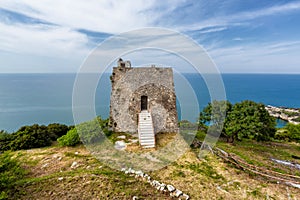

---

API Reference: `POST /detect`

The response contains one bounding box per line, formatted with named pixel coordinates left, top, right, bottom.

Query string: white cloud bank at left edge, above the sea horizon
left=0, top=23, right=88, bottom=57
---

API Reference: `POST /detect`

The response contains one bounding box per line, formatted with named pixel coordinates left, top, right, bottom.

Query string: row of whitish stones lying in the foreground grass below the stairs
left=121, top=168, right=190, bottom=200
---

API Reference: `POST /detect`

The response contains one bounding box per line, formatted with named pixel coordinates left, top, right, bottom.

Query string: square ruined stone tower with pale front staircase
left=110, top=59, right=178, bottom=147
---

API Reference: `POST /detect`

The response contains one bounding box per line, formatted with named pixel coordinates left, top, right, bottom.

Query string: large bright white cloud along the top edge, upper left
left=0, top=0, right=180, bottom=33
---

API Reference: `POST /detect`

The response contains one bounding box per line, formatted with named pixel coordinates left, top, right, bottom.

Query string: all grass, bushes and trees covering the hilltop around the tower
left=0, top=101, right=300, bottom=199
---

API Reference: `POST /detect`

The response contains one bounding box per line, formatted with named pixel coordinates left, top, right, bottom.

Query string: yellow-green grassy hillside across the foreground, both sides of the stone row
left=2, top=138, right=300, bottom=199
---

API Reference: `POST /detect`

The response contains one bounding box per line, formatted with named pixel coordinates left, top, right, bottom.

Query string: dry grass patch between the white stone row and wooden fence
left=153, top=151, right=300, bottom=199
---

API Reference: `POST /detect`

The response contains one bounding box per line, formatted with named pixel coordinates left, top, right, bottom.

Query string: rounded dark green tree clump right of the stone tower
left=198, top=100, right=276, bottom=142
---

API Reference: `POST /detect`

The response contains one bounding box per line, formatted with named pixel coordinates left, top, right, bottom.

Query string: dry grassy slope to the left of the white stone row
left=10, top=146, right=169, bottom=199
